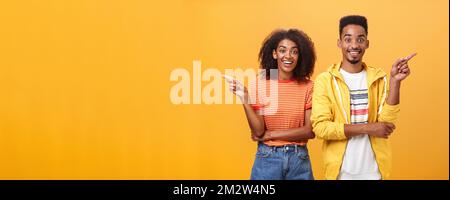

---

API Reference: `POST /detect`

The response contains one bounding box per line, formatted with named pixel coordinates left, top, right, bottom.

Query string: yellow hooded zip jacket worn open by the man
left=311, top=63, right=400, bottom=180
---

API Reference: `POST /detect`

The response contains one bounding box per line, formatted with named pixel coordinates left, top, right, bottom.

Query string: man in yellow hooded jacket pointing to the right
left=311, top=15, right=416, bottom=180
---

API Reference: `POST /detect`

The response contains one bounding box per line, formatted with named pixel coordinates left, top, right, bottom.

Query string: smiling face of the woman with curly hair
left=272, top=39, right=299, bottom=79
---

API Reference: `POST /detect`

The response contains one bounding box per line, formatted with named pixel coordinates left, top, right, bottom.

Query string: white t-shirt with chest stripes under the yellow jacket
left=338, top=68, right=381, bottom=180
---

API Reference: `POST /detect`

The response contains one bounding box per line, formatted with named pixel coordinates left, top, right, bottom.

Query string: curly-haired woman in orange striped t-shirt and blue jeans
left=229, top=29, right=316, bottom=180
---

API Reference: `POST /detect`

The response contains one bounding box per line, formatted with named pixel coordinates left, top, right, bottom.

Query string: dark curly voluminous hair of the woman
left=258, top=29, right=316, bottom=82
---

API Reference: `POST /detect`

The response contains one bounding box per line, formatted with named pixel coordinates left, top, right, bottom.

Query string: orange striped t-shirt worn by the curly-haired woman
left=249, top=80, right=313, bottom=146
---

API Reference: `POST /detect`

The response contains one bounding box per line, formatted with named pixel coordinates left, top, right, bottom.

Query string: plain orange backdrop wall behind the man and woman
left=0, top=0, right=449, bottom=179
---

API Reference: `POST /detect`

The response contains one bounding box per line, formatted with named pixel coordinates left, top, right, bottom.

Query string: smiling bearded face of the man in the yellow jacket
left=338, top=24, right=369, bottom=64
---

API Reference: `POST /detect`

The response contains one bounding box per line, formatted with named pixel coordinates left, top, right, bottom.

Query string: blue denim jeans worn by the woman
left=250, top=143, right=314, bottom=180
